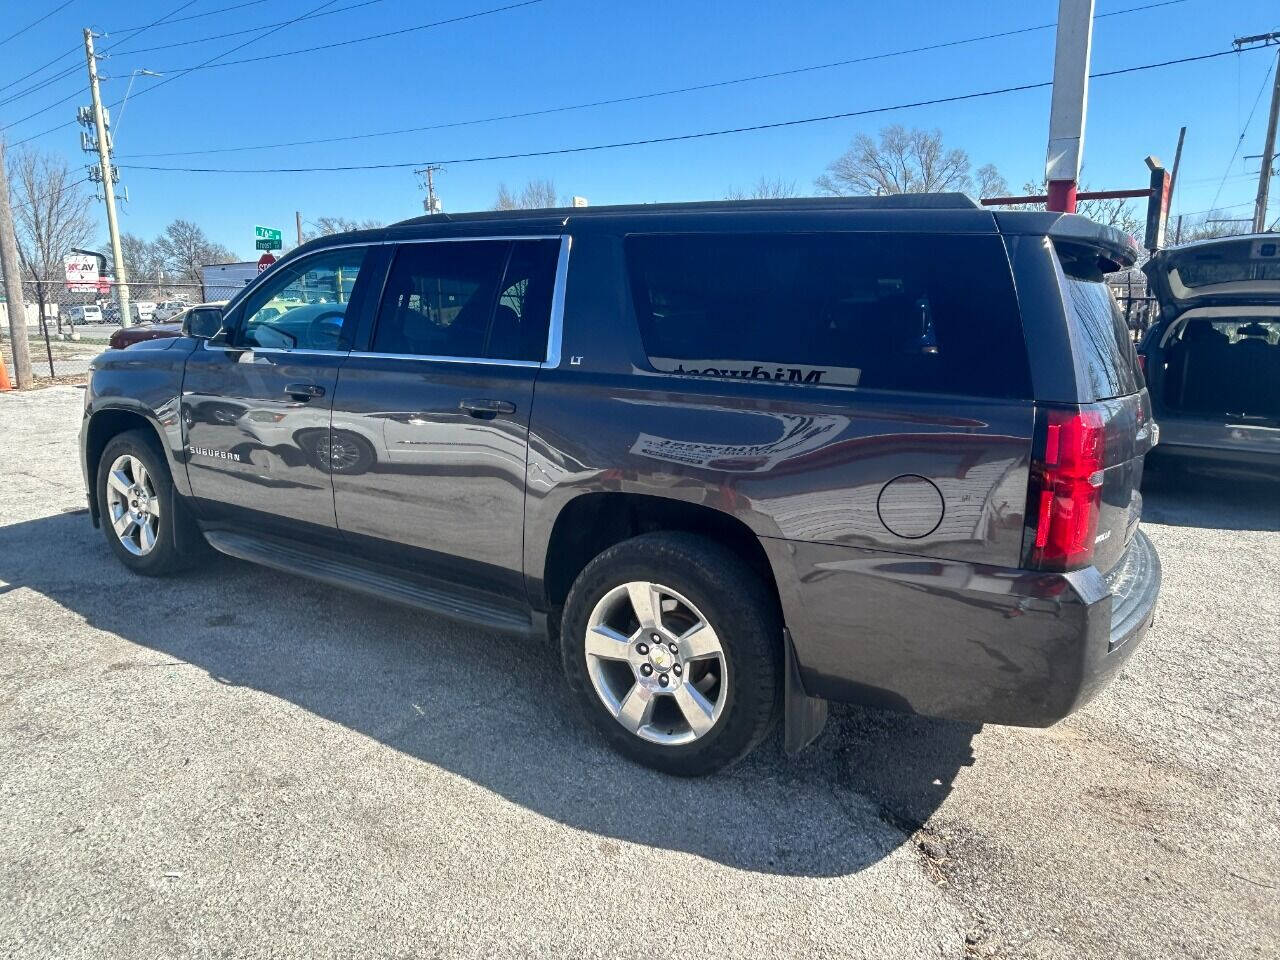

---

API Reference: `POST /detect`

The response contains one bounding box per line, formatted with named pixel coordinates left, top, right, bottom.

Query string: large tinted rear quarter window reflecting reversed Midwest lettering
left=626, top=233, right=1030, bottom=398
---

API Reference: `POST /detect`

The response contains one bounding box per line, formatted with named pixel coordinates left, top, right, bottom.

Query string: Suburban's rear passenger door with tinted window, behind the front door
left=333, top=237, right=567, bottom=596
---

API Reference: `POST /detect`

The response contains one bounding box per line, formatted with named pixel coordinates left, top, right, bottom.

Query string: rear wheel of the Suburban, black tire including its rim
left=561, top=532, right=782, bottom=777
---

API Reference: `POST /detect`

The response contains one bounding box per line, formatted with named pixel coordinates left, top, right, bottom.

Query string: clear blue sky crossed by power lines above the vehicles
left=0, top=0, right=1280, bottom=257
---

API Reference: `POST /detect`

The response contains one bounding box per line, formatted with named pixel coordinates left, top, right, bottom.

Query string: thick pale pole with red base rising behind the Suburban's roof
left=1044, top=0, right=1093, bottom=214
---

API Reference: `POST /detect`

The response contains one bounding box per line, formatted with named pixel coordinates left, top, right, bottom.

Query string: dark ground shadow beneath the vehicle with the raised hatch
left=1142, top=465, right=1280, bottom=531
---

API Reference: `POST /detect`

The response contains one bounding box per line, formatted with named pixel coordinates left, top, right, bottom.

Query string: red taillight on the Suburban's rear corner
left=1028, top=410, right=1106, bottom=570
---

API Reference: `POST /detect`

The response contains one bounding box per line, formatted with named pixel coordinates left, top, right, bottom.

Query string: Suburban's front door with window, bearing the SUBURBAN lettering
left=182, top=247, right=380, bottom=535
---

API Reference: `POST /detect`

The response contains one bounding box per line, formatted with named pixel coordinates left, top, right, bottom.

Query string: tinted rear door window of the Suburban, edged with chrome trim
left=371, top=239, right=559, bottom=361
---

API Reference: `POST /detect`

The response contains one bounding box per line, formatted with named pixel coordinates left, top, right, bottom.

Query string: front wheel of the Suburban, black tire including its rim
left=96, top=430, right=202, bottom=576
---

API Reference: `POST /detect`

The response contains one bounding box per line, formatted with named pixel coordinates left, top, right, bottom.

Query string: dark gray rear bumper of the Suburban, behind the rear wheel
left=764, top=530, right=1161, bottom=727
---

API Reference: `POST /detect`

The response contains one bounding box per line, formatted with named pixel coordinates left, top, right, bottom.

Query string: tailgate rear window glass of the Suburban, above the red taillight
left=1057, top=244, right=1143, bottom=399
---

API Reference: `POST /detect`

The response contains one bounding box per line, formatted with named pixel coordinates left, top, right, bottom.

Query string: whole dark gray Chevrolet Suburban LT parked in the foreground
left=82, top=196, right=1160, bottom=774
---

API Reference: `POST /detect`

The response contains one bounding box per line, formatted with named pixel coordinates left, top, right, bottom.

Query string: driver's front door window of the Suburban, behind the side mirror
left=237, top=247, right=366, bottom=349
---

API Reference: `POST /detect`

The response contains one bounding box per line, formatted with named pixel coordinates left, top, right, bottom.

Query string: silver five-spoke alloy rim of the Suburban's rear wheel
left=586, top=581, right=728, bottom=746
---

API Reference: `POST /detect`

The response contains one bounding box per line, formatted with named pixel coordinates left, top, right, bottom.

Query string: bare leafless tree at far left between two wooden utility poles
left=9, top=150, right=93, bottom=333
